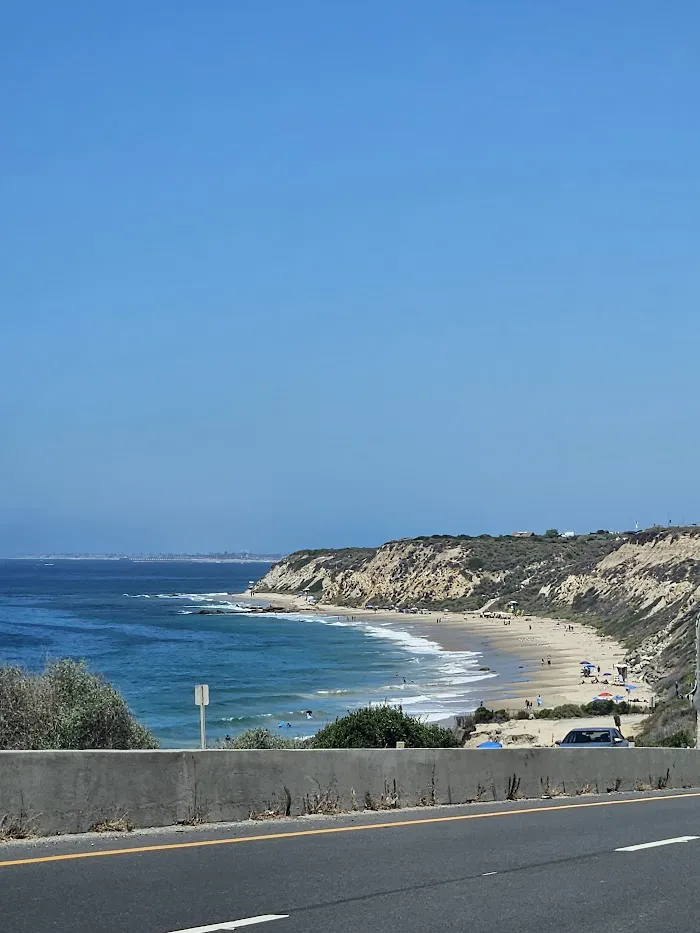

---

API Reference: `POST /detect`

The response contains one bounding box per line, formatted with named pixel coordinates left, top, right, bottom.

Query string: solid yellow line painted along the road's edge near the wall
left=0, top=791, right=700, bottom=868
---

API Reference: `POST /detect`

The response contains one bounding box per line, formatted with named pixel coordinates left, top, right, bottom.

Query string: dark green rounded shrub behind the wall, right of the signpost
left=311, top=706, right=458, bottom=748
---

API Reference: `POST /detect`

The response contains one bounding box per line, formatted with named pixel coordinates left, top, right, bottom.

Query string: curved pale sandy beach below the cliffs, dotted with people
left=239, top=591, right=652, bottom=713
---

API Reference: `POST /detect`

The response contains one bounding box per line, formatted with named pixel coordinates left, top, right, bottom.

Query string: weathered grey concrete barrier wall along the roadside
left=0, top=748, right=700, bottom=835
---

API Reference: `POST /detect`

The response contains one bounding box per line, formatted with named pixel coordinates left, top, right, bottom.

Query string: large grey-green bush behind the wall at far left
left=0, top=659, right=158, bottom=750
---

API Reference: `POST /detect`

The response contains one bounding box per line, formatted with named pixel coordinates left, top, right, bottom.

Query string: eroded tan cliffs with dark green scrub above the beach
left=259, top=527, right=700, bottom=680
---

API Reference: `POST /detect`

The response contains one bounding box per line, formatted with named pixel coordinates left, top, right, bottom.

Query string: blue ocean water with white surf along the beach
left=0, top=560, right=504, bottom=747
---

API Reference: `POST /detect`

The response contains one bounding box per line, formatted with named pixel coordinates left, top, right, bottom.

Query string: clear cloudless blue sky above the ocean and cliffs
left=0, top=0, right=700, bottom=554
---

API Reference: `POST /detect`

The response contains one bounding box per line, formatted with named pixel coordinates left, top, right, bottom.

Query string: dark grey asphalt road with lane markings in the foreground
left=0, top=792, right=700, bottom=933
